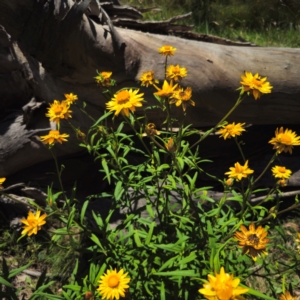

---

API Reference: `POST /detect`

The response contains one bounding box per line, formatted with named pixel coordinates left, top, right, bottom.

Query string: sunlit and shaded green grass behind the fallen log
left=122, top=0, right=300, bottom=48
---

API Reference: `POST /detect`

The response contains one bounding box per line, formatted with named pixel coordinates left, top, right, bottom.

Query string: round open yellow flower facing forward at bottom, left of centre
left=97, top=269, right=130, bottom=300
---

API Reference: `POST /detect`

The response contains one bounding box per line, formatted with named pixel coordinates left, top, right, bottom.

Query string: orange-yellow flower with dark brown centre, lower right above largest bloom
left=234, top=223, right=269, bottom=261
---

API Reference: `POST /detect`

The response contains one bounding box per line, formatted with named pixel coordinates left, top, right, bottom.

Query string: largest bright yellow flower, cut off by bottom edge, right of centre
left=199, top=267, right=249, bottom=300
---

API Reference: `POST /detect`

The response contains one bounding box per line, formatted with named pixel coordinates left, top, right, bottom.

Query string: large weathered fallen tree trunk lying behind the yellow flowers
left=0, top=0, right=300, bottom=176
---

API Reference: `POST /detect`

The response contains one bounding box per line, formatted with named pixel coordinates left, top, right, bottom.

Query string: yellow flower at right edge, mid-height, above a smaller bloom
left=269, top=127, right=300, bottom=154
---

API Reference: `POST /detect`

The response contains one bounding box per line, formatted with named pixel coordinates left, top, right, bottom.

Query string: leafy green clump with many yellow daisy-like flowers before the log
left=0, top=45, right=300, bottom=300
